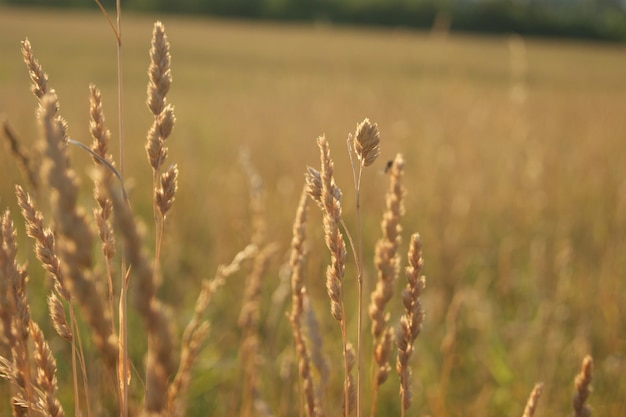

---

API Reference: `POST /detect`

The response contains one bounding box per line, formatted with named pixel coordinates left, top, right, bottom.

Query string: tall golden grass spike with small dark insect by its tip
left=369, top=154, right=405, bottom=410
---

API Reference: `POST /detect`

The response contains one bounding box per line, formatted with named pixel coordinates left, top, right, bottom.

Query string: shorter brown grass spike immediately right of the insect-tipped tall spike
left=396, top=233, right=426, bottom=416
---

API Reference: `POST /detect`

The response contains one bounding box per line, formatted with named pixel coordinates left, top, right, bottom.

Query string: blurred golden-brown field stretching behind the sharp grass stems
left=0, top=4, right=626, bottom=417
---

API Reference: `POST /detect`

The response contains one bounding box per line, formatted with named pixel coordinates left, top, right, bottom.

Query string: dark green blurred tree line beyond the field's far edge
left=0, top=0, right=626, bottom=40
